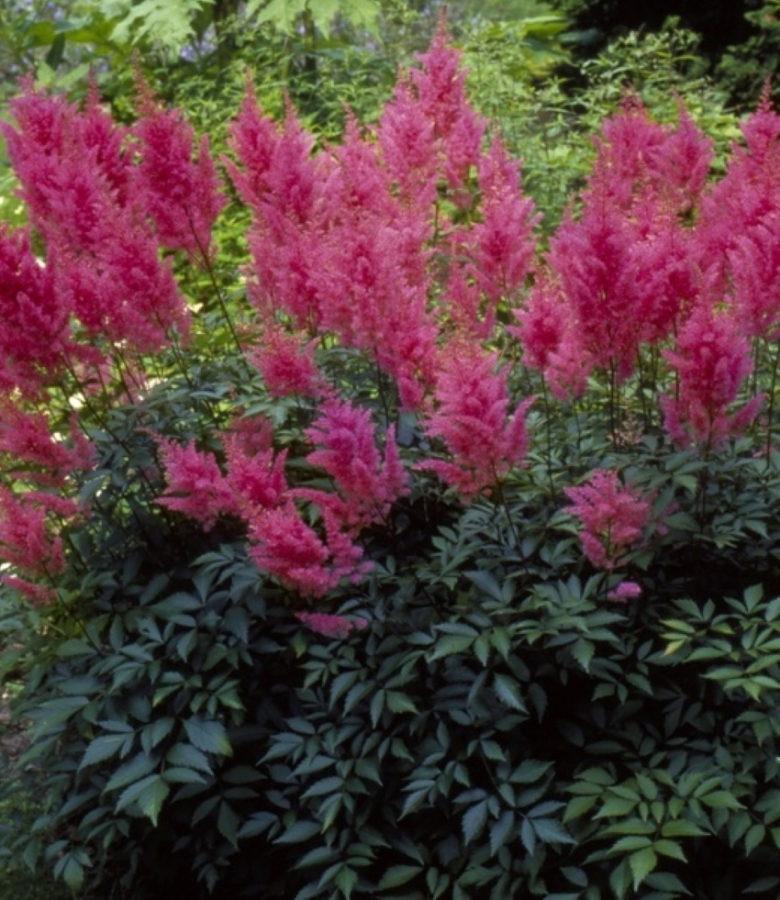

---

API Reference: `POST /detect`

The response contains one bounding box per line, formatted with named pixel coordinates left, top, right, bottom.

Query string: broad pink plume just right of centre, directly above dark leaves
left=416, top=343, right=533, bottom=500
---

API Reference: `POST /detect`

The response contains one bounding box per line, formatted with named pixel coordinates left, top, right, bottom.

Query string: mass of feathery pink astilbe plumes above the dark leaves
left=0, top=26, right=780, bottom=620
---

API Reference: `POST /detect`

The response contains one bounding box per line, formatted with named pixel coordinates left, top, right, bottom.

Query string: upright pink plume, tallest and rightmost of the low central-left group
left=306, top=399, right=409, bottom=529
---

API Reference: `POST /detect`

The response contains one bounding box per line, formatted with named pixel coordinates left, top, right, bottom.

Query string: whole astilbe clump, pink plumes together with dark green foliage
left=0, top=26, right=780, bottom=897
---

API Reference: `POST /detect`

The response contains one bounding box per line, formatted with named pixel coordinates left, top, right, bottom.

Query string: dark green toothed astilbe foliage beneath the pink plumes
left=6, top=361, right=780, bottom=900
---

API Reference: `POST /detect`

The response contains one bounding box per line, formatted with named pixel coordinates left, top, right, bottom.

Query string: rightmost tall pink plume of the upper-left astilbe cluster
left=132, top=81, right=227, bottom=258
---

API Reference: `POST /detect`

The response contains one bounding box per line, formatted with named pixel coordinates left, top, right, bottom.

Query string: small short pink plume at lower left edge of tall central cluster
left=249, top=325, right=324, bottom=397
